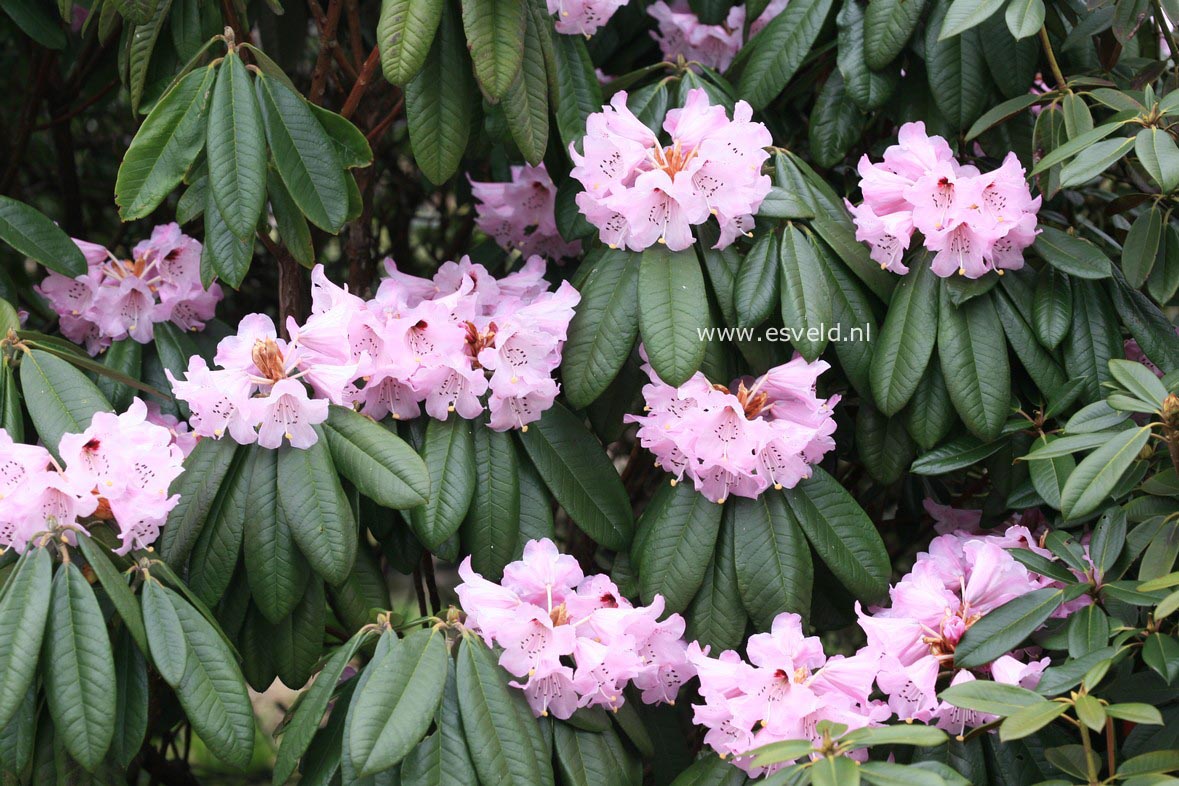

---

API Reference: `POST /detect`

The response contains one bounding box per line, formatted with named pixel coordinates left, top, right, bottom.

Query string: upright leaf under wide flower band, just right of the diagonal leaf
left=409, top=416, right=475, bottom=550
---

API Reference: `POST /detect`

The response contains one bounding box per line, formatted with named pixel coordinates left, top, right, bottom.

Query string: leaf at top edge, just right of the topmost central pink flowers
left=737, top=0, right=831, bottom=110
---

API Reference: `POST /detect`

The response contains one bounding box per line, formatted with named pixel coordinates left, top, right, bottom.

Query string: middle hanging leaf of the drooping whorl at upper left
left=208, top=52, right=269, bottom=239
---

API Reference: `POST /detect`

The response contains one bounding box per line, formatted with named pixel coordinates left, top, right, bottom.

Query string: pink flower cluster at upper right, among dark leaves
left=848, top=123, right=1040, bottom=278
